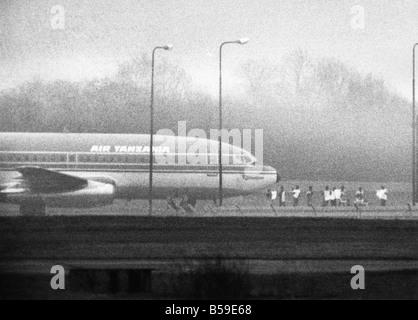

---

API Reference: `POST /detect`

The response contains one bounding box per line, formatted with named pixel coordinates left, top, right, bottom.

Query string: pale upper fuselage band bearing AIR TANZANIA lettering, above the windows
left=0, top=132, right=255, bottom=163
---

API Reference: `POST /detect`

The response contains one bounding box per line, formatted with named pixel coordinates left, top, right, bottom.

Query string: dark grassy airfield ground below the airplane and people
left=0, top=181, right=418, bottom=299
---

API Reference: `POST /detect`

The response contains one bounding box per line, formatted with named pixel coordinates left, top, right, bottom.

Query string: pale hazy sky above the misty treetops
left=0, top=0, right=418, bottom=99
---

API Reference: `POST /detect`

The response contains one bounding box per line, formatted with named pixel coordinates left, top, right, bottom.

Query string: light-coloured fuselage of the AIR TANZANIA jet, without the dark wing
left=0, top=134, right=278, bottom=206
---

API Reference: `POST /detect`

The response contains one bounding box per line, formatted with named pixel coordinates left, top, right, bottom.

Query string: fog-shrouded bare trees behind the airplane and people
left=0, top=49, right=412, bottom=182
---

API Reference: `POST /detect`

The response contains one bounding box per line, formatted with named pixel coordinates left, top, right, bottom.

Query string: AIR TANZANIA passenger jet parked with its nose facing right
left=0, top=133, right=280, bottom=216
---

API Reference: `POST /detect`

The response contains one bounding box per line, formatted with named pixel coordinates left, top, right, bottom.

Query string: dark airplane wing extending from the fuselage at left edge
left=1, top=167, right=88, bottom=193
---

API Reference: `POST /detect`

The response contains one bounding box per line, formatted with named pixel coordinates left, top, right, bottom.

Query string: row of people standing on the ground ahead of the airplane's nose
left=267, top=185, right=388, bottom=207
